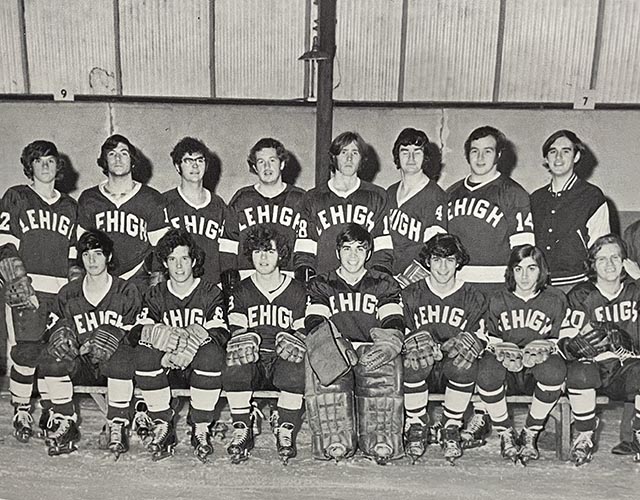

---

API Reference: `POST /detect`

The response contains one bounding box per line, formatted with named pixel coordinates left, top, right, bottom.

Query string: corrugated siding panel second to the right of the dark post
left=404, top=0, right=500, bottom=101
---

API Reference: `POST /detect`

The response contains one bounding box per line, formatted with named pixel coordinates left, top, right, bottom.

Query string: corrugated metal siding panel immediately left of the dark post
left=215, top=0, right=305, bottom=99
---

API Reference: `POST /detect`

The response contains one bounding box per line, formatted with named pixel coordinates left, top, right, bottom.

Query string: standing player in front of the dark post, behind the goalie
left=293, top=132, right=393, bottom=279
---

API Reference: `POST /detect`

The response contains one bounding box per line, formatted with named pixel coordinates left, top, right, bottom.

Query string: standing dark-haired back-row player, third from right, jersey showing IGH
left=387, top=128, right=447, bottom=288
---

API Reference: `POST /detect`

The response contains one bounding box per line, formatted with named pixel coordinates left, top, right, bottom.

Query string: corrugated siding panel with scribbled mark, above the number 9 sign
left=25, top=0, right=115, bottom=94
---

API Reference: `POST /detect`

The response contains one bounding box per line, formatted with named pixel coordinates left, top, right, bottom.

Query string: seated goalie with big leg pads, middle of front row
left=305, top=224, right=404, bottom=464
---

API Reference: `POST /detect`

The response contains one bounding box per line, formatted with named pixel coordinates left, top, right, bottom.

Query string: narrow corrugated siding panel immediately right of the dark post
left=333, top=0, right=402, bottom=101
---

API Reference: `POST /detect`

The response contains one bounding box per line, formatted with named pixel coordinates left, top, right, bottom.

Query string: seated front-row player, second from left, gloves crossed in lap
left=132, top=229, right=229, bottom=463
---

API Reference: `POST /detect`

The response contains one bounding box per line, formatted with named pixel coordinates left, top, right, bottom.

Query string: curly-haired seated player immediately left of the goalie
left=223, top=224, right=306, bottom=464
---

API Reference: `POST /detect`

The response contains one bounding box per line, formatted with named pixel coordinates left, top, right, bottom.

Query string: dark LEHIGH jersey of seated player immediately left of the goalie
left=229, top=275, right=306, bottom=351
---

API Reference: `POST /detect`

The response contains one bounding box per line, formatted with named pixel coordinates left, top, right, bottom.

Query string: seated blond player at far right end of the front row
left=559, top=234, right=640, bottom=465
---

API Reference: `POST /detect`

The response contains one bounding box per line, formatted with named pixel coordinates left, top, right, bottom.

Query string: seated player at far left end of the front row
left=38, top=229, right=142, bottom=459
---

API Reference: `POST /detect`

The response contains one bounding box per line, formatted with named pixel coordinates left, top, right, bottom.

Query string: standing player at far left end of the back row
left=0, top=140, right=77, bottom=442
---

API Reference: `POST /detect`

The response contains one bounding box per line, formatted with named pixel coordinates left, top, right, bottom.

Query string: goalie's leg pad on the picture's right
left=354, top=346, right=404, bottom=462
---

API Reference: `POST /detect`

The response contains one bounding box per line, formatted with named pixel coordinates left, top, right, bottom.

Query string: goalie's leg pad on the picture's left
left=304, top=361, right=357, bottom=460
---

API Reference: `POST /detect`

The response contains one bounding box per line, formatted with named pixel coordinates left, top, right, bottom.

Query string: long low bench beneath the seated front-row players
left=74, top=385, right=609, bottom=460
